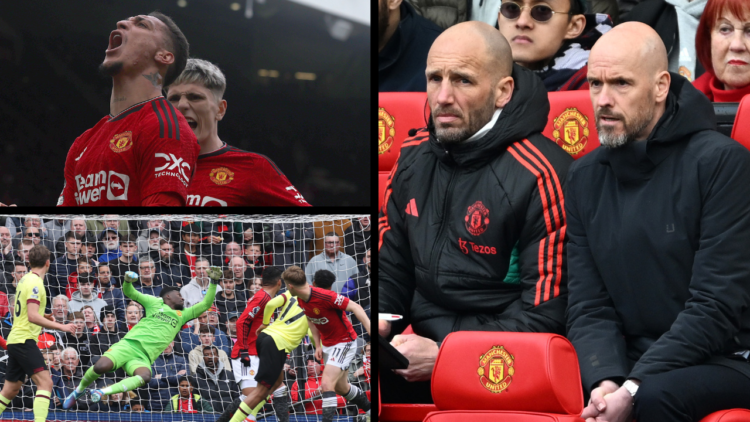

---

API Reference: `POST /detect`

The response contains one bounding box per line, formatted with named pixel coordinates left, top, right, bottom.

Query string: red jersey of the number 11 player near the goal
left=297, top=287, right=357, bottom=347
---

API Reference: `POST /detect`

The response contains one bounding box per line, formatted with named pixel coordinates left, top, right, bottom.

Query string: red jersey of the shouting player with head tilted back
left=57, top=97, right=200, bottom=206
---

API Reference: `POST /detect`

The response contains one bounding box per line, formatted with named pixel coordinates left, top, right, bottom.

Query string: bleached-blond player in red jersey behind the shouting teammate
left=167, top=59, right=310, bottom=207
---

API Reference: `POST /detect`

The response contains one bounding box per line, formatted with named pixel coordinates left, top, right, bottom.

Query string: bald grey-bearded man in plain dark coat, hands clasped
left=565, top=22, right=750, bottom=422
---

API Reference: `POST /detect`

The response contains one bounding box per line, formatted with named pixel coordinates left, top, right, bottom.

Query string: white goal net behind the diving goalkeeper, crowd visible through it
left=0, top=214, right=371, bottom=422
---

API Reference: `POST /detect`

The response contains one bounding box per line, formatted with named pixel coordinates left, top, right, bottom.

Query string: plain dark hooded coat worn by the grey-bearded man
left=565, top=73, right=750, bottom=389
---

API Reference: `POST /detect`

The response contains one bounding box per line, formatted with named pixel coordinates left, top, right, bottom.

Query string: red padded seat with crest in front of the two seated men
left=425, top=331, right=583, bottom=422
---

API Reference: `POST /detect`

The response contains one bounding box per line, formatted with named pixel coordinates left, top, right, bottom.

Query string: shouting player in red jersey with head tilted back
left=57, top=12, right=200, bottom=206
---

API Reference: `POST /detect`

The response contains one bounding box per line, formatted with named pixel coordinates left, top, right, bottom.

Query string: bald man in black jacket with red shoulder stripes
left=378, top=21, right=573, bottom=402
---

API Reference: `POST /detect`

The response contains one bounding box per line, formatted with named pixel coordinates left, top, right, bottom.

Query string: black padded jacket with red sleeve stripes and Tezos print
left=378, top=66, right=572, bottom=341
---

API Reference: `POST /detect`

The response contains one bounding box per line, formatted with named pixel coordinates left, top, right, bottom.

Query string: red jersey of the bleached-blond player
left=187, top=143, right=310, bottom=207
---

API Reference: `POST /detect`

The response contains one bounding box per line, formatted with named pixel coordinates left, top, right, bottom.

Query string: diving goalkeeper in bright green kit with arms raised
left=63, top=267, right=222, bottom=409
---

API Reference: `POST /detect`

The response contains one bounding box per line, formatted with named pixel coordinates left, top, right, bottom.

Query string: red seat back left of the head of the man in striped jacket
left=378, top=92, right=429, bottom=172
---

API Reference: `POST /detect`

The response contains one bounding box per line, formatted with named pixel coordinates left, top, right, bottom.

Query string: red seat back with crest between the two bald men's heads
left=542, top=91, right=599, bottom=159
